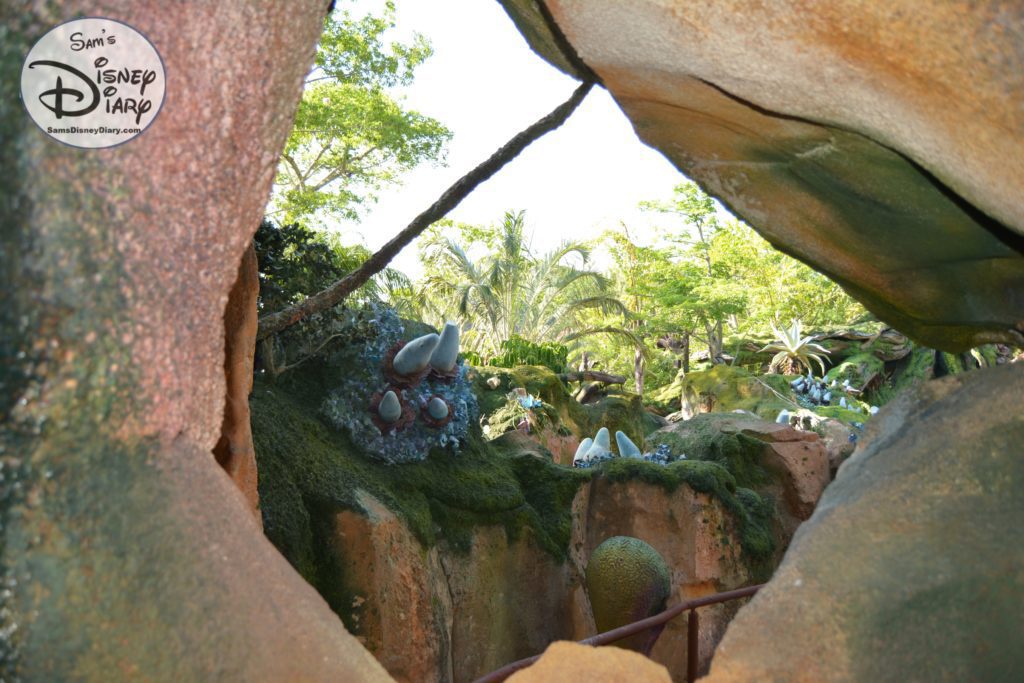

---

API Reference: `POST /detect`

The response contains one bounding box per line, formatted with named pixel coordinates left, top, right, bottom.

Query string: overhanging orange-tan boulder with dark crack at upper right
left=502, top=0, right=1024, bottom=350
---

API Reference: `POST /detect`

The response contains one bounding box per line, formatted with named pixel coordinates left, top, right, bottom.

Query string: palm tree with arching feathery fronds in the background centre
left=411, top=211, right=631, bottom=356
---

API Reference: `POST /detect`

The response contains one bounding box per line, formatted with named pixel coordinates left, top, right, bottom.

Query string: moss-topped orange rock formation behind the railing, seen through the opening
left=251, top=349, right=828, bottom=681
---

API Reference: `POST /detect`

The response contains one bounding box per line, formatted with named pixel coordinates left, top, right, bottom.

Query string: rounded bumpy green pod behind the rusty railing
left=586, top=536, right=672, bottom=653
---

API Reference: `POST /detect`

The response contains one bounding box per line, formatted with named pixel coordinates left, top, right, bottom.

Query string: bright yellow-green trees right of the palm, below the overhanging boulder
left=586, top=183, right=865, bottom=394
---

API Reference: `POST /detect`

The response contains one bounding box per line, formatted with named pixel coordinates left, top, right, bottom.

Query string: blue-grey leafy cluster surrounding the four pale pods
left=321, top=306, right=478, bottom=465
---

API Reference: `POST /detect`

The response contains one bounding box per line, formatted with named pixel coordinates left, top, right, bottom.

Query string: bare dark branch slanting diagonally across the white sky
left=256, top=81, right=594, bottom=340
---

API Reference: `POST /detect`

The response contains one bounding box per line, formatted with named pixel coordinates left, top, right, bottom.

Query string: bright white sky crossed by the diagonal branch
left=338, top=0, right=684, bottom=278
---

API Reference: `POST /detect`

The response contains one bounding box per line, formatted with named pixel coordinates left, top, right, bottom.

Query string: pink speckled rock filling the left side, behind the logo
left=0, top=0, right=387, bottom=682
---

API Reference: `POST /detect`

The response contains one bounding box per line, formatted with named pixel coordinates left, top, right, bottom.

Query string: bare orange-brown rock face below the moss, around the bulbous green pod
left=323, top=466, right=802, bottom=682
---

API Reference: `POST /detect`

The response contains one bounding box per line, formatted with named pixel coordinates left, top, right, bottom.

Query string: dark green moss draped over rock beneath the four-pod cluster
left=250, top=371, right=590, bottom=573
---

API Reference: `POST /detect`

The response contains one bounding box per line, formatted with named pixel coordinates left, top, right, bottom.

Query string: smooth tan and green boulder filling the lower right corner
left=707, top=364, right=1024, bottom=683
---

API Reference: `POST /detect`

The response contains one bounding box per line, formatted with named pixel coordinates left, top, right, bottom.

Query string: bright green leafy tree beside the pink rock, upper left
left=270, top=0, right=452, bottom=223
